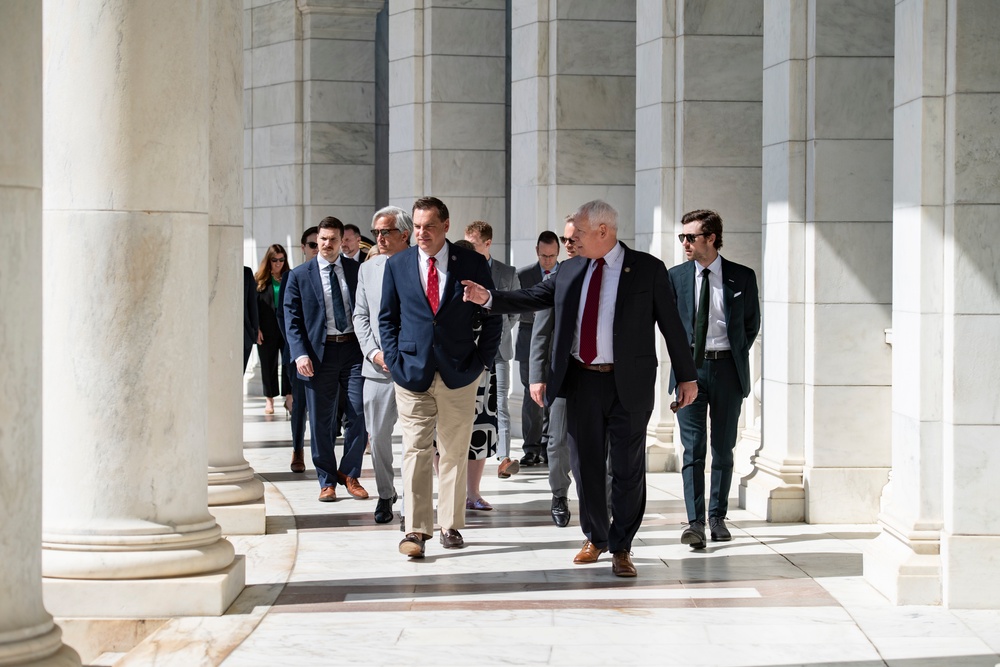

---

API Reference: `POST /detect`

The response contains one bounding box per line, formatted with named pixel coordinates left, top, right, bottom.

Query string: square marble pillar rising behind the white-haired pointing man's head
left=511, top=0, right=636, bottom=265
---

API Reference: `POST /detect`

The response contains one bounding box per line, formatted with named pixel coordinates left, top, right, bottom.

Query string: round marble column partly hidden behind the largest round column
left=207, top=0, right=264, bottom=535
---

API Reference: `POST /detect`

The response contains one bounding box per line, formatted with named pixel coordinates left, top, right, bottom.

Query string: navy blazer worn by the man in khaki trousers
left=378, top=243, right=502, bottom=392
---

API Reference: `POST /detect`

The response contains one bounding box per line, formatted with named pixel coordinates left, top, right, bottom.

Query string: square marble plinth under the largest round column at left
left=42, top=556, right=246, bottom=618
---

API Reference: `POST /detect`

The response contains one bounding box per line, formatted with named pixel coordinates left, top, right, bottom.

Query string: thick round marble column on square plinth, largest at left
left=42, top=0, right=244, bottom=618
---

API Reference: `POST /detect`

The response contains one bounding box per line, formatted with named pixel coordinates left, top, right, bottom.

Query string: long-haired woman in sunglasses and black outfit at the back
left=254, top=243, right=292, bottom=416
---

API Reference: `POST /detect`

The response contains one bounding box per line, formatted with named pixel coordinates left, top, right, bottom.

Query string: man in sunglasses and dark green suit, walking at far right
left=670, top=210, right=760, bottom=549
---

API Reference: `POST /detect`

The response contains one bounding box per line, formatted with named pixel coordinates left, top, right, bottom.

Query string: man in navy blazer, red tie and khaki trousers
left=379, top=197, right=502, bottom=558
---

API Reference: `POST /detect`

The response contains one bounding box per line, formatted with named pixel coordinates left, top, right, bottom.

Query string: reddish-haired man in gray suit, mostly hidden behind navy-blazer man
left=465, top=220, right=520, bottom=479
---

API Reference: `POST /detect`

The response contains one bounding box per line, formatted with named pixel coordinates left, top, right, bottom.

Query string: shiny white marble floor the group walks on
left=103, top=400, right=1000, bottom=667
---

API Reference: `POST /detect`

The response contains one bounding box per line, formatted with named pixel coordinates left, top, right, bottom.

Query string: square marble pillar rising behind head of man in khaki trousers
left=389, top=0, right=508, bottom=253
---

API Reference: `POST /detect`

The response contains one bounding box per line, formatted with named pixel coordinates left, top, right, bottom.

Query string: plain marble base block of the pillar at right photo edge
left=941, top=535, right=1000, bottom=609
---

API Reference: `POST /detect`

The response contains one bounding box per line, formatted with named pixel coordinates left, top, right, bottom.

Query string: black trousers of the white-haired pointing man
left=564, top=362, right=652, bottom=552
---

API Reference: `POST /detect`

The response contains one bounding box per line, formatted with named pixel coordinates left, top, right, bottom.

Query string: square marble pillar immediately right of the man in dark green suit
left=743, top=0, right=893, bottom=523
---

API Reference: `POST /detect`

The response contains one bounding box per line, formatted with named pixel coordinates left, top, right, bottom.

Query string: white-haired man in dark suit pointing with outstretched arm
left=465, top=200, right=697, bottom=577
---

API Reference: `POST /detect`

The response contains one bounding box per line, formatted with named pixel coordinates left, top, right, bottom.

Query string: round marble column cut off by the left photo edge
left=0, top=0, right=80, bottom=667
